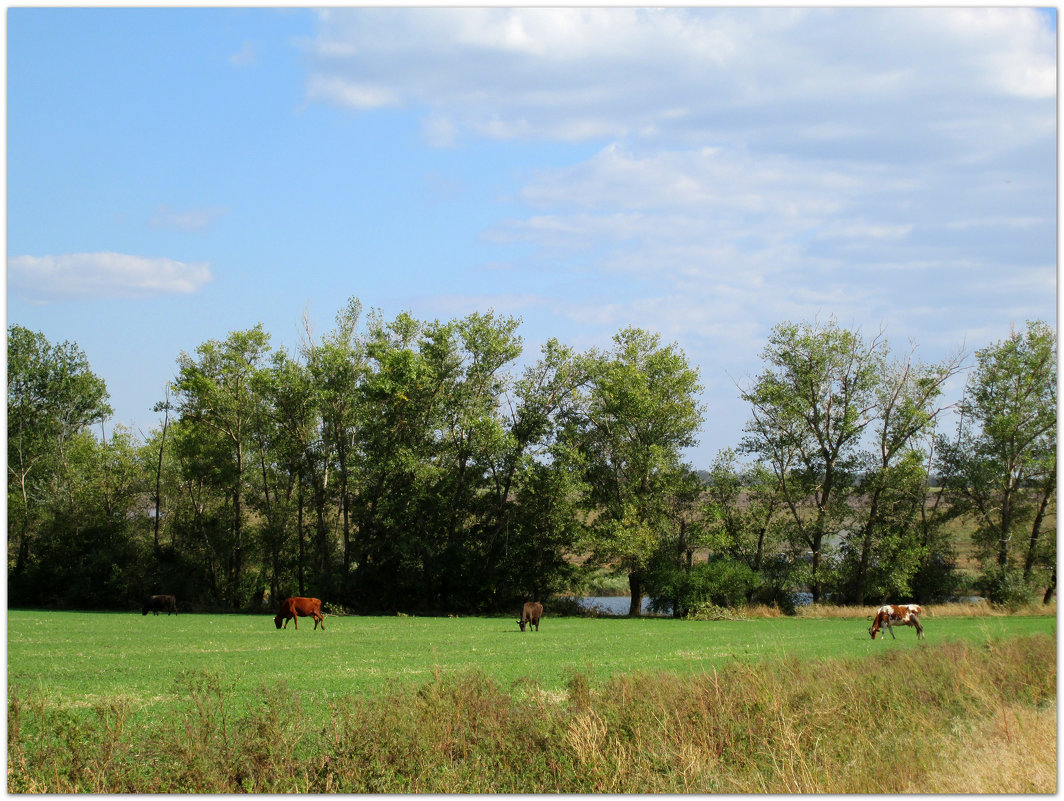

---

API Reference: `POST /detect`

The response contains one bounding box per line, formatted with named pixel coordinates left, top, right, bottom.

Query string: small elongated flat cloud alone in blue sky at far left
left=7, top=252, right=212, bottom=302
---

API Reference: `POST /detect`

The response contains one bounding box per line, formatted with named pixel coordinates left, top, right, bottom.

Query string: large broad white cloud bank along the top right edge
left=305, top=7, right=1057, bottom=149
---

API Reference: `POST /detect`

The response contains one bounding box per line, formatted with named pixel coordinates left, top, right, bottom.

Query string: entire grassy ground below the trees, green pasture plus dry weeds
left=7, top=611, right=1057, bottom=794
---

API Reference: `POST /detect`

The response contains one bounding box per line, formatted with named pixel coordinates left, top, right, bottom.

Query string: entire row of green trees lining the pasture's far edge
left=7, top=299, right=1055, bottom=614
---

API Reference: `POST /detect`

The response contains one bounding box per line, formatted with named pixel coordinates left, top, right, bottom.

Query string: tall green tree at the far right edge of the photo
left=940, top=321, right=1057, bottom=601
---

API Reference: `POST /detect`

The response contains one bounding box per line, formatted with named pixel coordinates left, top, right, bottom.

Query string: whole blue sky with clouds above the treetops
left=6, top=7, right=1058, bottom=466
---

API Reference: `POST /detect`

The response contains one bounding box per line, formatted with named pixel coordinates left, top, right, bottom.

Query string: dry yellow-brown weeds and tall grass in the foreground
left=7, top=635, right=1057, bottom=794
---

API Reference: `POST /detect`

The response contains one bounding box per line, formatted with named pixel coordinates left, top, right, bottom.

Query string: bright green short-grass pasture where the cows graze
left=7, top=610, right=1055, bottom=717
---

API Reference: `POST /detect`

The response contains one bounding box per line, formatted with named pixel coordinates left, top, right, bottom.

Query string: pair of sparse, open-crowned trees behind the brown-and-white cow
left=742, top=319, right=961, bottom=603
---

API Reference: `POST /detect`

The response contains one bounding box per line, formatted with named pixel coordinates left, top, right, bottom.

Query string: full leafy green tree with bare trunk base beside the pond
left=571, top=328, right=703, bottom=615
